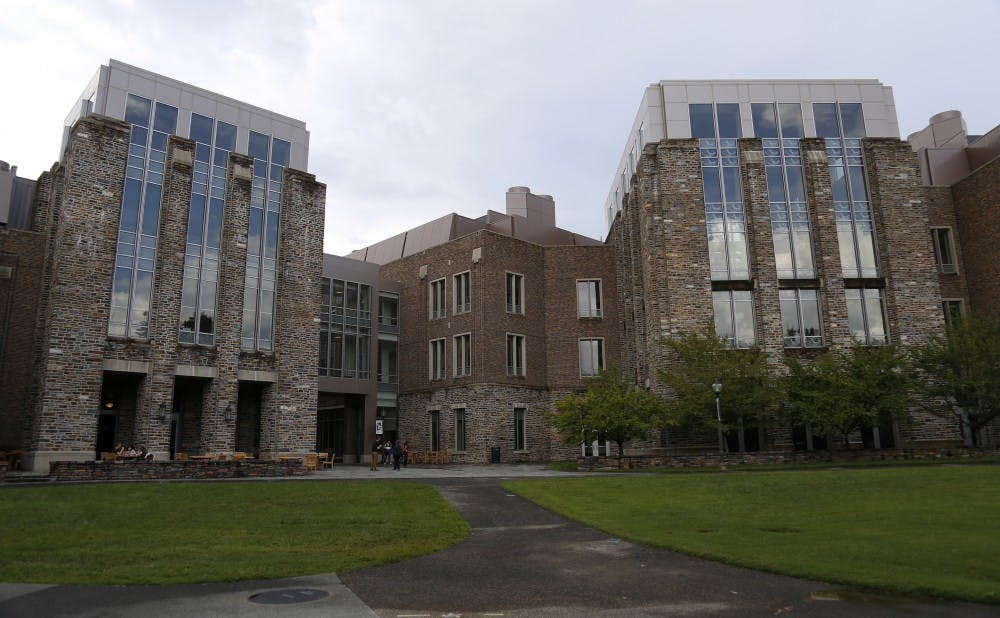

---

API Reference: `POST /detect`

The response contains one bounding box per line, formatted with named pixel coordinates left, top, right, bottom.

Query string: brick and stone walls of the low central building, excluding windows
left=381, top=230, right=621, bottom=463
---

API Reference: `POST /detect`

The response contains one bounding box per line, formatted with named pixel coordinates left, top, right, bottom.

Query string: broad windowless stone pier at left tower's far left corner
left=25, top=116, right=128, bottom=467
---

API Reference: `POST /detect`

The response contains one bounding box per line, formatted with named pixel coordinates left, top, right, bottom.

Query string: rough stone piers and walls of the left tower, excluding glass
left=19, top=116, right=325, bottom=471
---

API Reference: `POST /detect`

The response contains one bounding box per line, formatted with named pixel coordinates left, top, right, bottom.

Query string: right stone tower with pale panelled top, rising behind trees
left=605, top=80, right=968, bottom=450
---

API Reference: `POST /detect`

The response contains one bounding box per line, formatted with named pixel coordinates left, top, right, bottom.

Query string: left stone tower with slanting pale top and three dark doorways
left=0, top=60, right=325, bottom=471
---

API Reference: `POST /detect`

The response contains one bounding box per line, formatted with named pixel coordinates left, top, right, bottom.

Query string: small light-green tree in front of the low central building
left=551, top=368, right=663, bottom=466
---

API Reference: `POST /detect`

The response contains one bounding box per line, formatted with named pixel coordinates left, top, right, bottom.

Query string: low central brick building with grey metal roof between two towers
left=350, top=187, right=620, bottom=463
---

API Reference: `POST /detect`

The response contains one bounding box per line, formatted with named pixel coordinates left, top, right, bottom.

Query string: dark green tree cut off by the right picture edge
left=913, top=316, right=1000, bottom=443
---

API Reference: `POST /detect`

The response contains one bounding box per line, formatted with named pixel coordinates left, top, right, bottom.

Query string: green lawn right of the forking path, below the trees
left=504, top=465, right=1000, bottom=603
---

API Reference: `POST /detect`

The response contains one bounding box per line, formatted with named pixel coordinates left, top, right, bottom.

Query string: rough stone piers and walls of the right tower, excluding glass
left=609, top=138, right=960, bottom=450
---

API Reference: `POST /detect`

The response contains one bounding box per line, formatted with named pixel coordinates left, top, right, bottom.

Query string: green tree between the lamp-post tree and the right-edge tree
left=784, top=345, right=914, bottom=448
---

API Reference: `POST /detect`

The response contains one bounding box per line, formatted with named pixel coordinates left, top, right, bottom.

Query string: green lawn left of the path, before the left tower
left=0, top=482, right=469, bottom=584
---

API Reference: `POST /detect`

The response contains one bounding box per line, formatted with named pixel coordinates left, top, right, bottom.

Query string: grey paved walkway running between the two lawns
left=0, top=465, right=998, bottom=618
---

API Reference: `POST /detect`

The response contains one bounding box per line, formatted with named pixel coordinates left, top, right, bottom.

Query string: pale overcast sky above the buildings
left=0, top=0, right=1000, bottom=254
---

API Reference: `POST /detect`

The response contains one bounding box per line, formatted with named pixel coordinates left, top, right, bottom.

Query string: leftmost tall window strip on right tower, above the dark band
left=688, top=103, right=750, bottom=281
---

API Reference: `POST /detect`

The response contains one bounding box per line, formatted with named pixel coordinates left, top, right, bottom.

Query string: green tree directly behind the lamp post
left=658, top=326, right=781, bottom=438
